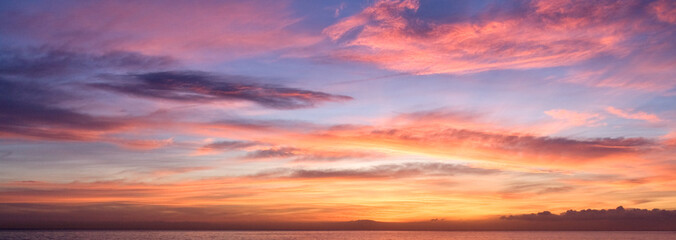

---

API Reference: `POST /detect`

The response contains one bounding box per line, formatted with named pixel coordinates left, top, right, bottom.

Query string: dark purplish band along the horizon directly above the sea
left=0, top=206, right=676, bottom=231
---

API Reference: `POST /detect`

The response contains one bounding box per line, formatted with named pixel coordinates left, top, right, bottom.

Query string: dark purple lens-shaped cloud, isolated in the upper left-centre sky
left=93, top=71, right=352, bottom=109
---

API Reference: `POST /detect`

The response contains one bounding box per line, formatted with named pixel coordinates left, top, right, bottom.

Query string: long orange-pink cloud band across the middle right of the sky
left=189, top=109, right=663, bottom=167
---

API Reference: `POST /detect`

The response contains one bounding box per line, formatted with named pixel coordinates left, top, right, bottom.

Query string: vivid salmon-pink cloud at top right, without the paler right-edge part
left=324, top=0, right=640, bottom=74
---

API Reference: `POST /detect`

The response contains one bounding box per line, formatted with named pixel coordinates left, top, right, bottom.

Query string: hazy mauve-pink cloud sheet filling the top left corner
left=0, top=0, right=321, bottom=60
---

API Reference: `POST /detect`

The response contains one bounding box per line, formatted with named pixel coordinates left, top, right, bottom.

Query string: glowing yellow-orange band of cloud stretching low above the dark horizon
left=0, top=158, right=674, bottom=222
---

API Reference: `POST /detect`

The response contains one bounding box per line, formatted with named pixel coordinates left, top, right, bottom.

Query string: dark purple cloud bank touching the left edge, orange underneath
left=0, top=46, right=175, bottom=140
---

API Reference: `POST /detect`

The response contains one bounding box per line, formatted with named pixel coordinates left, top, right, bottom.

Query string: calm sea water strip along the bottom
left=0, top=231, right=676, bottom=240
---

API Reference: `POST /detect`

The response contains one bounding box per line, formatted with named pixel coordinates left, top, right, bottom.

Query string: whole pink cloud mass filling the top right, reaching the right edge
left=323, top=0, right=676, bottom=96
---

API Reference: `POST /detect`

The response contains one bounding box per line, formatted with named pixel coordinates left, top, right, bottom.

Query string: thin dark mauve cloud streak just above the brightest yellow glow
left=255, top=163, right=500, bottom=179
